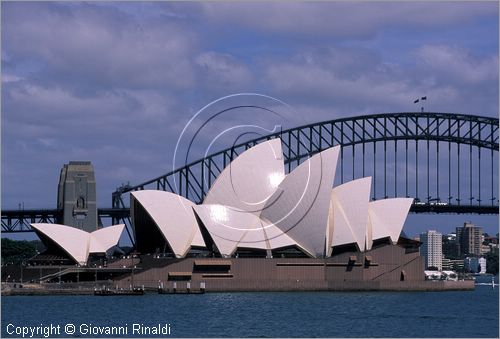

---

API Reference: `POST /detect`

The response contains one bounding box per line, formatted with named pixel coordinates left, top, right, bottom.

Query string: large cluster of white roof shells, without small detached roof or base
left=130, top=139, right=413, bottom=258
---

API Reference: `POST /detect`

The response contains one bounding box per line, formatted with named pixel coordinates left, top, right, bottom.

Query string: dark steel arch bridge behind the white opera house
left=2, top=112, right=499, bottom=241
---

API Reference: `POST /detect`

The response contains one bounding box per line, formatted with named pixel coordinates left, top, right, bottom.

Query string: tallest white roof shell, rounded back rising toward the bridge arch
left=203, top=139, right=285, bottom=215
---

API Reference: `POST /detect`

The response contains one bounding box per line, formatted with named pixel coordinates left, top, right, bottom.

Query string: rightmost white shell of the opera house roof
left=368, top=198, right=413, bottom=244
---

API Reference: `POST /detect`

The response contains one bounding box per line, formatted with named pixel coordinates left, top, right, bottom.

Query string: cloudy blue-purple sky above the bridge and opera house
left=1, top=1, right=499, bottom=239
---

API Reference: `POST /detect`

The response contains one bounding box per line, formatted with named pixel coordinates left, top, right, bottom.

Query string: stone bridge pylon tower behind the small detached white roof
left=57, top=161, right=98, bottom=232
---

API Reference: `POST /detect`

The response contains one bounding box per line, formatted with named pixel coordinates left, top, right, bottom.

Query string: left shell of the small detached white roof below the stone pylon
left=31, top=224, right=89, bottom=265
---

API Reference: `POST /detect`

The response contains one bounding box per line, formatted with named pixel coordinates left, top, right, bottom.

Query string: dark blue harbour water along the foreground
left=2, top=286, right=499, bottom=338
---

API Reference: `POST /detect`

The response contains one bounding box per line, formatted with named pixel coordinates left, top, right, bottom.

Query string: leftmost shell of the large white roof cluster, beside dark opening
left=131, top=190, right=205, bottom=257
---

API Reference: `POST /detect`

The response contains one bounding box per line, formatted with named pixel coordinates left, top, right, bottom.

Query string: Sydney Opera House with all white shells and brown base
left=27, top=139, right=462, bottom=291
